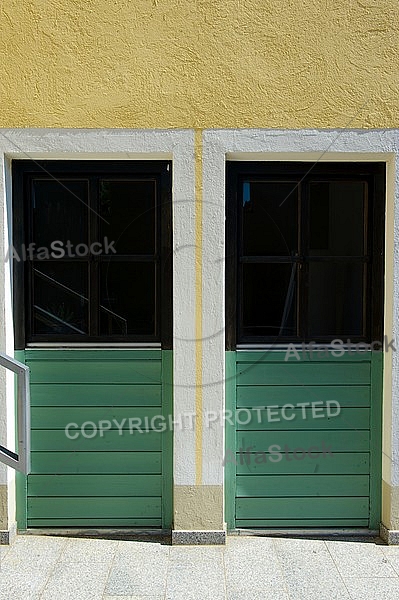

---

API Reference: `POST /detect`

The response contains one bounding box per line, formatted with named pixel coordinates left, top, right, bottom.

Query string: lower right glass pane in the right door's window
left=308, top=262, right=364, bottom=337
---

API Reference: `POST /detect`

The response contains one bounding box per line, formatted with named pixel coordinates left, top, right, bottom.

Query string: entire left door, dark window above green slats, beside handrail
left=13, top=160, right=173, bottom=529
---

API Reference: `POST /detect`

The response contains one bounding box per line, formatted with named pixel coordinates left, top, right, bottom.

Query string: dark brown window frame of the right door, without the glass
left=226, top=161, right=386, bottom=350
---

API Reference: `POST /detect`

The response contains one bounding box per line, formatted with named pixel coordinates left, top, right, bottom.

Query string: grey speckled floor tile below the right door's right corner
left=326, top=541, right=396, bottom=577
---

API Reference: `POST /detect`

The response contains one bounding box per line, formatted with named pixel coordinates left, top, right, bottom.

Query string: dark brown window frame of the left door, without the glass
left=11, top=159, right=173, bottom=349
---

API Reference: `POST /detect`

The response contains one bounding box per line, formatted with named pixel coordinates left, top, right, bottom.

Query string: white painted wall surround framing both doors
left=0, top=129, right=399, bottom=528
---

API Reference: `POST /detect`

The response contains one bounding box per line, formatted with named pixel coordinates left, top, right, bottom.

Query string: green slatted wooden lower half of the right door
left=226, top=351, right=382, bottom=529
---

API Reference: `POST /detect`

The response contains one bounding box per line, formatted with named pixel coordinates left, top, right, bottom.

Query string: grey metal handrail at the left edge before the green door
left=0, top=352, right=30, bottom=475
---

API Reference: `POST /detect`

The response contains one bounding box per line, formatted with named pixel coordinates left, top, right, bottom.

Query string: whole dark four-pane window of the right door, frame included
left=226, top=162, right=385, bottom=349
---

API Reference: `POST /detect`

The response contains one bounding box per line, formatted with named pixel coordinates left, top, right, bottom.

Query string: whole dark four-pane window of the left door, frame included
left=12, top=160, right=171, bottom=348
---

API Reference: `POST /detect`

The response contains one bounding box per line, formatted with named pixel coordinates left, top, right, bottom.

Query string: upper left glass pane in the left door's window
left=32, top=179, right=88, bottom=253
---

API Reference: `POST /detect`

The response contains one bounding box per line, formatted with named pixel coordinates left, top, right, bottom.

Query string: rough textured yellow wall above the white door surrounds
left=0, top=0, right=399, bottom=128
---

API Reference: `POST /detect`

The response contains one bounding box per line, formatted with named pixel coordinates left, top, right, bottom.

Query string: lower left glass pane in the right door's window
left=242, top=263, right=297, bottom=337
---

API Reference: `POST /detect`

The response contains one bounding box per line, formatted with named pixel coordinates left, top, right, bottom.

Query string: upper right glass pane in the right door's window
left=309, top=181, right=366, bottom=256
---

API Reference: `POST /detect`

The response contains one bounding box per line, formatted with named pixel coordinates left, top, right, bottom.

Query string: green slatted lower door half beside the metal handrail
left=18, top=350, right=172, bottom=529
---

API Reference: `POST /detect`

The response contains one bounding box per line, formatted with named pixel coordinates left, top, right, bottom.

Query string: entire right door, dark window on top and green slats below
left=225, top=163, right=388, bottom=529
